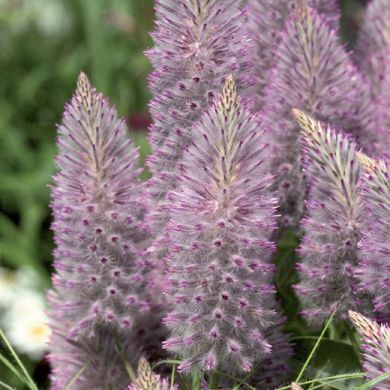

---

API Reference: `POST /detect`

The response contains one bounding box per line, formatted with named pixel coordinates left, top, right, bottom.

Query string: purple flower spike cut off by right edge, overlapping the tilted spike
left=357, top=153, right=390, bottom=322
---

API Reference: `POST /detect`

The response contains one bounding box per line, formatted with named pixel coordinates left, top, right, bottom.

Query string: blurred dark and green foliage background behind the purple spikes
left=0, top=0, right=372, bottom=389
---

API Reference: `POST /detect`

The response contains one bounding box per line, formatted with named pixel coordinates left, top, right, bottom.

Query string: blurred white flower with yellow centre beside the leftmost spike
left=4, top=289, right=50, bottom=359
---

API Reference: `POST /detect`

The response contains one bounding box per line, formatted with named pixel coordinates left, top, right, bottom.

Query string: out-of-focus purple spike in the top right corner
left=354, top=0, right=390, bottom=155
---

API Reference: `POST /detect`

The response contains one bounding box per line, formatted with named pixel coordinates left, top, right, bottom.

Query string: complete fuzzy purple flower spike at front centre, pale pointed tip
left=165, top=77, right=278, bottom=372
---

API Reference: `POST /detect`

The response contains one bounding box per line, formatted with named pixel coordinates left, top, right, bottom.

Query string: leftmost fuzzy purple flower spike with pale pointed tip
left=49, top=73, right=164, bottom=389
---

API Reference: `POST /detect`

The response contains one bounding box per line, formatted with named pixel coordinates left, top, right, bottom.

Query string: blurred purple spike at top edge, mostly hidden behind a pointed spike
left=245, top=0, right=340, bottom=111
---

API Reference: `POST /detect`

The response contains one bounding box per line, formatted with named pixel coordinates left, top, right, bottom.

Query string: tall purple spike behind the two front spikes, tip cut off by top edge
left=148, top=0, right=253, bottom=238
